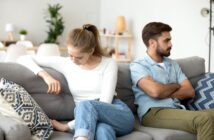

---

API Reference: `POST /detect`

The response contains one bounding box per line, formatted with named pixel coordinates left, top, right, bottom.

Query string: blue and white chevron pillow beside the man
left=187, top=73, right=214, bottom=110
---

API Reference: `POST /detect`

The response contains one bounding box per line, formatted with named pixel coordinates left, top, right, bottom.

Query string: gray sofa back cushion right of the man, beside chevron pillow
left=176, top=56, right=205, bottom=87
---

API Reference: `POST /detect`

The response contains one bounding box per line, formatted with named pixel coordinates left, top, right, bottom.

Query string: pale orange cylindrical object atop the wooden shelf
left=116, top=16, right=126, bottom=35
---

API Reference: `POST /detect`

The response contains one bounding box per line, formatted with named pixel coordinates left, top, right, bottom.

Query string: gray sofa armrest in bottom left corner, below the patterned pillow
left=0, top=114, right=31, bottom=140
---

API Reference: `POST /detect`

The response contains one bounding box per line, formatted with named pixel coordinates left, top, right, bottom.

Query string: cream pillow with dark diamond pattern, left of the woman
left=0, top=78, right=53, bottom=140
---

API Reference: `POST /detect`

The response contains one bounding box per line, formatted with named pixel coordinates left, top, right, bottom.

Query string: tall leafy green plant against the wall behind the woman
left=45, top=4, right=64, bottom=44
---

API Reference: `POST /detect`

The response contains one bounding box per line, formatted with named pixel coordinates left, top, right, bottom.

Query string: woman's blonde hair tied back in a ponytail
left=67, top=24, right=104, bottom=56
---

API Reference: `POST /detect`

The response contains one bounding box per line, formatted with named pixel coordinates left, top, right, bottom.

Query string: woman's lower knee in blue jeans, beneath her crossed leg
left=96, top=123, right=116, bottom=140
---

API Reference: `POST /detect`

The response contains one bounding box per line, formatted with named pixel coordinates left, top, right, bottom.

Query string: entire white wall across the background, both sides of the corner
left=0, top=0, right=214, bottom=72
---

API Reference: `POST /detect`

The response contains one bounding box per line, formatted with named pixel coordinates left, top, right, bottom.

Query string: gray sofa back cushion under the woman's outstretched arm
left=0, top=63, right=75, bottom=120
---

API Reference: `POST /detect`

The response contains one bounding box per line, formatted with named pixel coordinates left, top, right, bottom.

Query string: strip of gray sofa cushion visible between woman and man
left=116, top=63, right=137, bottom=113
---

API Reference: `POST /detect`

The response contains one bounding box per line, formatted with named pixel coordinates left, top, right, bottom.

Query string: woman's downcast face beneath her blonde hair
left=68, top=45, right=92, bottom=65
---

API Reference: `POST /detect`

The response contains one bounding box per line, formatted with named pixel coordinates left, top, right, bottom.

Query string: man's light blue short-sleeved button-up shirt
left=130, top=54, right=187, bottom=119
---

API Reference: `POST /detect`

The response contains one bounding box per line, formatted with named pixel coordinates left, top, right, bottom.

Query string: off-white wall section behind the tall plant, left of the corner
left=0, top=0, right=100, bottom=45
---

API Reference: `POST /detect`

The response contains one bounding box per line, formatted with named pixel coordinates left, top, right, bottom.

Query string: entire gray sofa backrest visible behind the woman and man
left=0, top=56, right=205, bottom=120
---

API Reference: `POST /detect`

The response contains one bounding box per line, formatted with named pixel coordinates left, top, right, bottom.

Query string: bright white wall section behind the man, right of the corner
left=100, top=0, right=214, bottom=72
